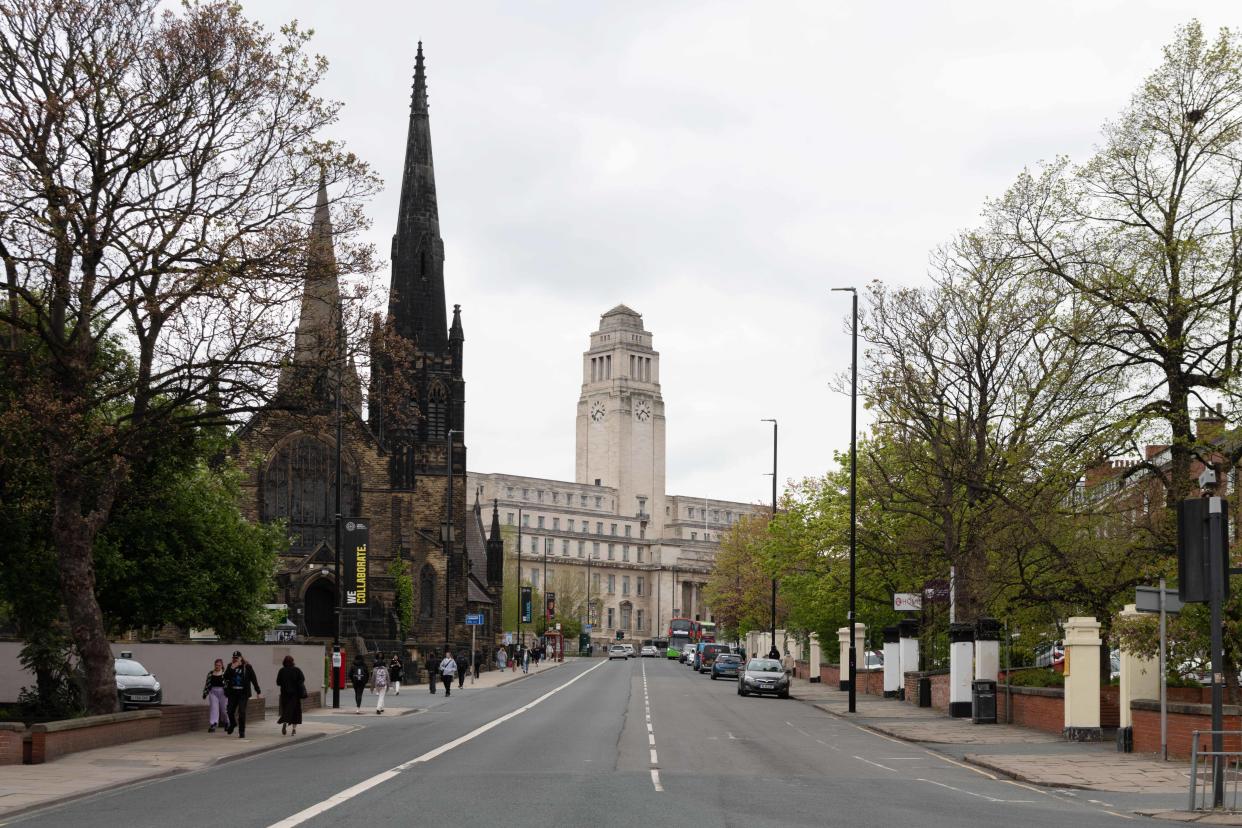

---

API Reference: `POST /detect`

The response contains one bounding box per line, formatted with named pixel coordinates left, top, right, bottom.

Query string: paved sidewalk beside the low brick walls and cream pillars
left=794, top=680, right=1190, bottom=794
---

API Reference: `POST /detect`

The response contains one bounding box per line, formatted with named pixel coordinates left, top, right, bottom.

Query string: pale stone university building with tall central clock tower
left=469, top=305, right=764, bottom=646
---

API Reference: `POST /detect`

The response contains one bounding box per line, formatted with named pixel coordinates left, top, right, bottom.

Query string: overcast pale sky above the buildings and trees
left=245, top=0, right=1242, bottom=503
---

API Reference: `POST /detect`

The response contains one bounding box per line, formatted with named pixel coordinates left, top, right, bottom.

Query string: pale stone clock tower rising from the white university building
left=575, top=304, right=664, bottom=538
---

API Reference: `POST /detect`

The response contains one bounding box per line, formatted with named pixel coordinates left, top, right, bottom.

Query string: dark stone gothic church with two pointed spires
left=237, top=43, right=503, bottom=653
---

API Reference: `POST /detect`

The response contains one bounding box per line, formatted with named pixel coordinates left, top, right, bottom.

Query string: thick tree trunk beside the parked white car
left=52, top=489, right=117, bottom=715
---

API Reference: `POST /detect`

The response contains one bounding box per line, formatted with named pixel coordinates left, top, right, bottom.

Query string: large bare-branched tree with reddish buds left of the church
left=0, top=0, right=375, bottom=713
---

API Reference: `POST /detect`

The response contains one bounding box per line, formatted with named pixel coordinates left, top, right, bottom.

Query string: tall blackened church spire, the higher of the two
left=389, top=42, right=448, bottom=353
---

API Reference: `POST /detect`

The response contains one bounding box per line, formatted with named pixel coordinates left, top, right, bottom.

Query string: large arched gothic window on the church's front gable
left=260, top=434, right=359, bottom=554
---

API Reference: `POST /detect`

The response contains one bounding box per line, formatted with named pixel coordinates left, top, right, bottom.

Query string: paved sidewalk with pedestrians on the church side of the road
left=0, top=663, right=561, bottom=826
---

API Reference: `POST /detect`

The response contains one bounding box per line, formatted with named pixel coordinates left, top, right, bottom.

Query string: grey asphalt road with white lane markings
left=15, top=659, right=1157, bottom=828
